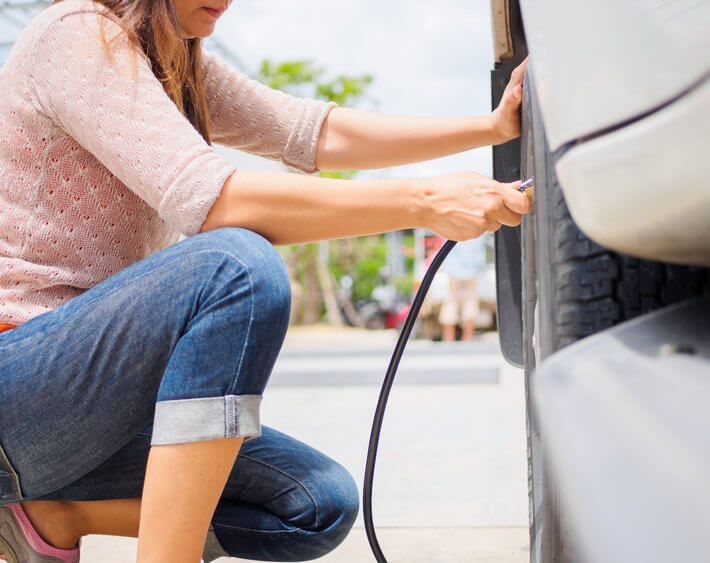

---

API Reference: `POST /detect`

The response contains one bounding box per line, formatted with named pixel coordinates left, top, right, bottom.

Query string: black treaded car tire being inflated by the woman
left=521, top=73, right=708, bottom=563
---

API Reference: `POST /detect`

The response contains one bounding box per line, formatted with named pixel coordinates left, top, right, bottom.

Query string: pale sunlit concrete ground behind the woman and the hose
left=82, top=327, right=528, bottom=563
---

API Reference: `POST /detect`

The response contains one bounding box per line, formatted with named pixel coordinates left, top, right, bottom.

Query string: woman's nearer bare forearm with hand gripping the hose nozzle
left=200, top=170, right=530, bottom=244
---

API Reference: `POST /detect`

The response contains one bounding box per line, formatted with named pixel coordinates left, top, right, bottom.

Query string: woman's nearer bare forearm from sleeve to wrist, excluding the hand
left=200, top=169, right=423, bottom=244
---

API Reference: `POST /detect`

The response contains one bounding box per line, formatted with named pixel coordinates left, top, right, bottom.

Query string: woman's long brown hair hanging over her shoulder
left=53, top=0, right=211, bottom=144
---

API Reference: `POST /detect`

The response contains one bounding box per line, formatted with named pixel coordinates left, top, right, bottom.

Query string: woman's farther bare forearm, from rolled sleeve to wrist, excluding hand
left=316, top=107, right=506, bottom=170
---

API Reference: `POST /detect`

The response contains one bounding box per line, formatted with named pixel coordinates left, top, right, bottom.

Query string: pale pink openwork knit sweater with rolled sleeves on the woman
left=0, top=0, right=338, bottom=325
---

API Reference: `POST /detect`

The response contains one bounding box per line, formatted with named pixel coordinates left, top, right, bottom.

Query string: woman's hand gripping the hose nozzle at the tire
left=415, top=172, right=531, bottom=241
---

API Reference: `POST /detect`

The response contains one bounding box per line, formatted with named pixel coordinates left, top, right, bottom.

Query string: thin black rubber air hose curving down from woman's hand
left=362, top=240, right=457, bottom=563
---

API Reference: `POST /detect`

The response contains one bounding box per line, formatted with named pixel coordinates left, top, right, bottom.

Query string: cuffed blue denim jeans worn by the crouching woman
left=0, top=227, right=359, bottom=561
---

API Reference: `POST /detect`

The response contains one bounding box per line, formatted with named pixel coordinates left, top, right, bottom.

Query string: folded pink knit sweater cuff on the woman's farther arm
left=281, top=98, right=338, bottom=174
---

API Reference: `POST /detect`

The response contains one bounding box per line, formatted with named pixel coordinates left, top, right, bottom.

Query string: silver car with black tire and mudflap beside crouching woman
left=491, top=0, right=710, bottom=563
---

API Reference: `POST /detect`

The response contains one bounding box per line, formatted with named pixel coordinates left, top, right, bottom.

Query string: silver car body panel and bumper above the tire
left=521, top=0, right=710, bottom=265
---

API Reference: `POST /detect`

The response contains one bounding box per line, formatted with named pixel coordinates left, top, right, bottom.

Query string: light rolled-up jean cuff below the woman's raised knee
left=150, top=395, right=262, bottom=446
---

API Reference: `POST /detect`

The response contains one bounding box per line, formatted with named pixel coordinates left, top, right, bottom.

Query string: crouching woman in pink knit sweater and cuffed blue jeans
left=0, top=0, right=529, bottom=563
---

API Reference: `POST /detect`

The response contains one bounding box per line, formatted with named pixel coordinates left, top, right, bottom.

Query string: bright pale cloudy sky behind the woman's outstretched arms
left=0, top=0, right=493, bottom=178
